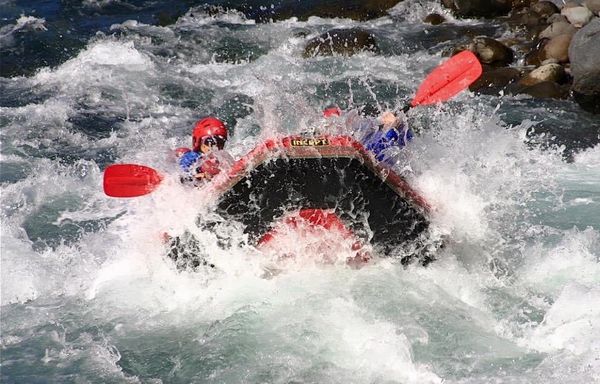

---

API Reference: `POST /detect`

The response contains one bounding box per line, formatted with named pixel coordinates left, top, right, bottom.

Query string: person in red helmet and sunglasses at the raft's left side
left=176, top=116, right=233, bottom=185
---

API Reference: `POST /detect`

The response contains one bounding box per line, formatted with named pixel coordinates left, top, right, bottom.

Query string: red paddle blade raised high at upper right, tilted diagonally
left=410, top=51, right=483, bottom=107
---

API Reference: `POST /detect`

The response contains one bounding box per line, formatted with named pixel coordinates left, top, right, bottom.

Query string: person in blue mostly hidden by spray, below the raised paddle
left=323, top=105, right=414, bottom=165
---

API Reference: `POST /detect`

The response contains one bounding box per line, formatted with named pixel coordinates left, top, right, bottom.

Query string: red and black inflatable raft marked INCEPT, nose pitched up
left=199, top=135, right=430, bottom=264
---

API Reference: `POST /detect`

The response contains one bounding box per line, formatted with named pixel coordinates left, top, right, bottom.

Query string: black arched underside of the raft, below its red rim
left=217, top=157, right=429, bottom=252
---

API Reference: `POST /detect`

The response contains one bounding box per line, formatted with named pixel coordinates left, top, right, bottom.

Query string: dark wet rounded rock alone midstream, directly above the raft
left=304, top=28, right=379, bottom=57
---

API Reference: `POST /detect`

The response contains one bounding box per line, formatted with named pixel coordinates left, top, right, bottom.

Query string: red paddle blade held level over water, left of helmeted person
left=104, top=164, right=162, bottom=197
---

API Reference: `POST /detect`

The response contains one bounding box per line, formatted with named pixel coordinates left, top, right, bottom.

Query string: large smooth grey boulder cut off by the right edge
left=569, top=18, right=600, bottom=113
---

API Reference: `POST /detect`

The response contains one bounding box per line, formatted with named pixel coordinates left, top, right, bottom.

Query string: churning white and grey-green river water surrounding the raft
left=0, top=1, right=600, bottom=383
